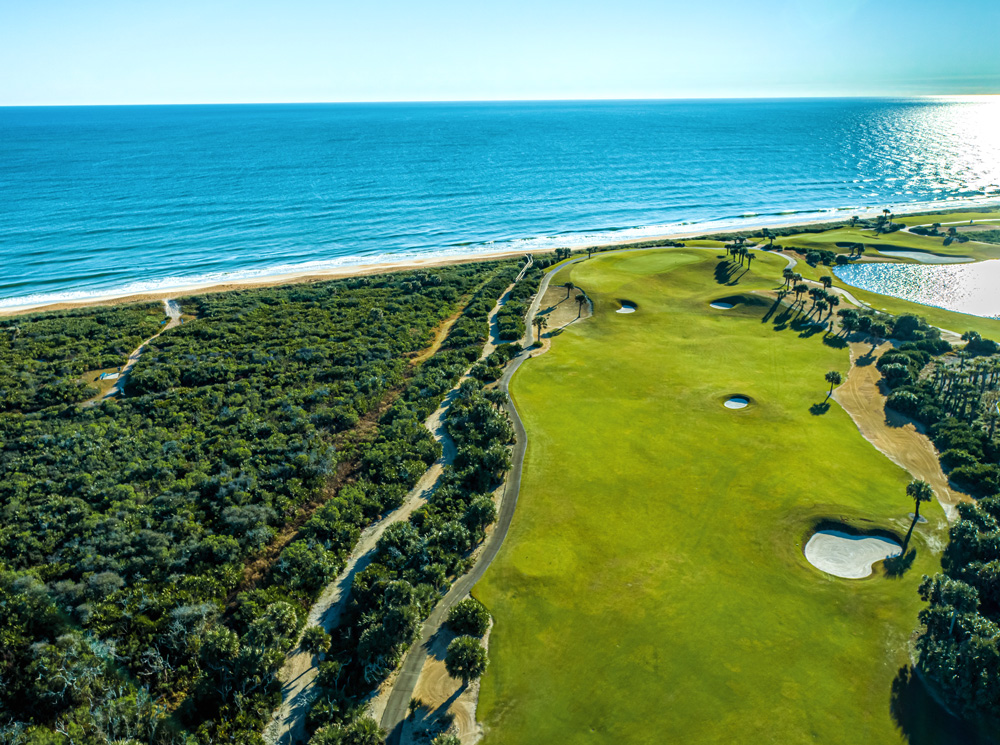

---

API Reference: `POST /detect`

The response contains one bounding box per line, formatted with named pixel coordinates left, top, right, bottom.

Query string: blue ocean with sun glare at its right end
left=0, top=97, right=1000, bottom=307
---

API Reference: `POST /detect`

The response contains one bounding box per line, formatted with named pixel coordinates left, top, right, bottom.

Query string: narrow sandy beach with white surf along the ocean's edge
left=0, top=201, right=1000, bottom=317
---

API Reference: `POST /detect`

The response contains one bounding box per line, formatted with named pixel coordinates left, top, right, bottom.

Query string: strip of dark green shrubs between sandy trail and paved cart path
left=309, top=378, right=514, bottom=734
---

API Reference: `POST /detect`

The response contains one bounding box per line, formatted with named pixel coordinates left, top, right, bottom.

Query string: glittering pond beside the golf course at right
left=833, top=259, right=1000, bottom=318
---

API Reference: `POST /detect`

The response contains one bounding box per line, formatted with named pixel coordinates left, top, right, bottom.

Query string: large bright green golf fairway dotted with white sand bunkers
left=475, top=249, right=946, bottom=745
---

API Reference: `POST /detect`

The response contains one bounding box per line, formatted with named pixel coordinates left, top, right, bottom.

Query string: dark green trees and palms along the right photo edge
left=856, top=316, right=1000, bottom=721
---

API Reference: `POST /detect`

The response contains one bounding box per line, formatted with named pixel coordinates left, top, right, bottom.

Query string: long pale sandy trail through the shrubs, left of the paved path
left=264, top=260, right=531, bottom=745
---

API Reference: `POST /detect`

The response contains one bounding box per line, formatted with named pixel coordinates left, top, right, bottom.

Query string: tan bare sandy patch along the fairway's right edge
left=833, top=342, right=971, bottom=522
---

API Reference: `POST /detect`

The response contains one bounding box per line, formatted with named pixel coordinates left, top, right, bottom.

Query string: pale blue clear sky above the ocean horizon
left=0, top=0, right=1000, bottom=106
